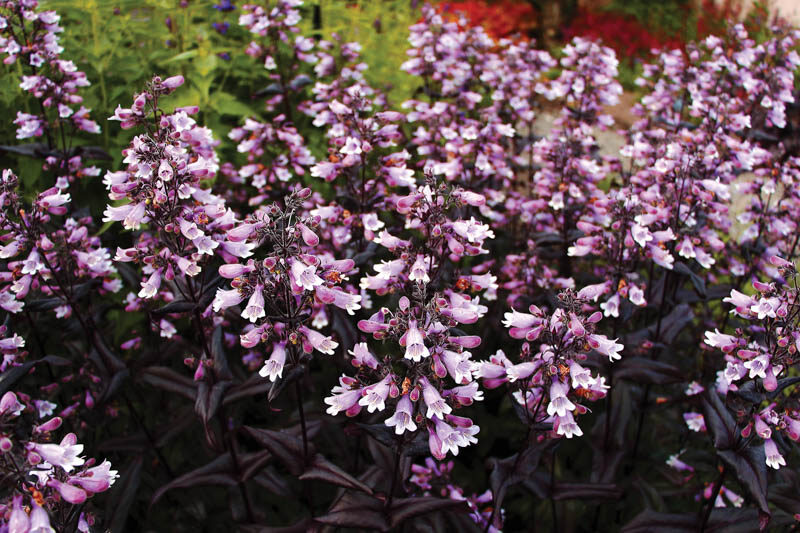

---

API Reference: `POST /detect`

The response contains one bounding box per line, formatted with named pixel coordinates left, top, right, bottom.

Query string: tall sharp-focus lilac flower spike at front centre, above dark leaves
left=325, top=175, right=494, bottom=501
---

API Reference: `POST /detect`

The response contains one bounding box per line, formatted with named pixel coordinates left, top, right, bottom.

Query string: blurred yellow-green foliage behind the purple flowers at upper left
left=0, top=0, right=419, bottom=194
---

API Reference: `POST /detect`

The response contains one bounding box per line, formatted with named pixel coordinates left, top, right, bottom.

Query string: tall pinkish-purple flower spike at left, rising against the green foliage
left=103, top=76, right=241, bottom=340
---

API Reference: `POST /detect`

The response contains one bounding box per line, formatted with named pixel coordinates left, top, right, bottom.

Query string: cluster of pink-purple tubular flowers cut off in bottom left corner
left=0, top=391, right=119, bottom=533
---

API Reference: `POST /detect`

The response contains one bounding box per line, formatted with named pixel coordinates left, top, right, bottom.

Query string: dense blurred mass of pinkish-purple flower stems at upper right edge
left=622, top=25, right=800, bottom=284
